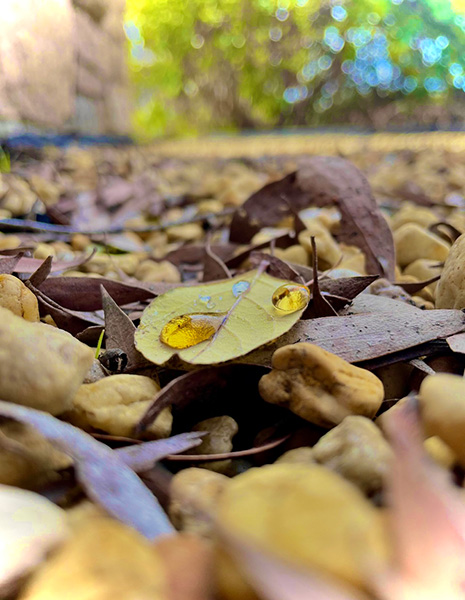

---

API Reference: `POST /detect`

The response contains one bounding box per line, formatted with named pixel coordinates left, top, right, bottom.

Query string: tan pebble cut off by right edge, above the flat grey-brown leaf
left=436, top=234, right=465, bottom=310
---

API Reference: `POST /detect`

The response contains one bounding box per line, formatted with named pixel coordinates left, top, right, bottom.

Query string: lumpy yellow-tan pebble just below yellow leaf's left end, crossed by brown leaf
left=63, top=374, right=173, bottom=439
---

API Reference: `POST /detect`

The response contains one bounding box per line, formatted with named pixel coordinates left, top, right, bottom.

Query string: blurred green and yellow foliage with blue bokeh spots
left=125, top=0, right=465, bottom=137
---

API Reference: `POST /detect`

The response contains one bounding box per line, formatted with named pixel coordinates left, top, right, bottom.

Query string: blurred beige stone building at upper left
left=0, top=0, right=131, bottom=135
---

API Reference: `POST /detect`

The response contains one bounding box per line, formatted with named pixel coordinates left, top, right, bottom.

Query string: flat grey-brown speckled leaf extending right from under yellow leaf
left=237, top=310, right=465, bottom=366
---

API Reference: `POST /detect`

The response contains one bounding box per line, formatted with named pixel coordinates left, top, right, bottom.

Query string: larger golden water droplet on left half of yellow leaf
left=160, top=313, right=223, bottom=350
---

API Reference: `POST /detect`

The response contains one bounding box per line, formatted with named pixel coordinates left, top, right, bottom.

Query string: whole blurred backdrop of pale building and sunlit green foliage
left=0, top=0, right=465, bottom=140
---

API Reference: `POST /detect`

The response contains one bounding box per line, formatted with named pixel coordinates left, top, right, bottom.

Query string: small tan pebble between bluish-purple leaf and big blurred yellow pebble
left=169, top=467, right=230, bottom=537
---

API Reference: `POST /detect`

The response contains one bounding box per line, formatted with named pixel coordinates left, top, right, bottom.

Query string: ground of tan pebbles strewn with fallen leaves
left=0, top=146, right=465, bottom=600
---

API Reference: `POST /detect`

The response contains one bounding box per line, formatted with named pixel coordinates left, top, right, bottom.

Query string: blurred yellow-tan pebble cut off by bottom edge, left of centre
left=20, top=516, right=170, bottom=600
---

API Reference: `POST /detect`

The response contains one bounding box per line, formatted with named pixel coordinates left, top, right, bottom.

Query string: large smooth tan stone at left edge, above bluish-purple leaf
left=0, top=308, right=94, bottom=415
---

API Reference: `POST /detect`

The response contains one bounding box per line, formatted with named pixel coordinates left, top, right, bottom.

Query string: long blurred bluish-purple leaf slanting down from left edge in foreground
left=0, top=401, right=173, bottom=539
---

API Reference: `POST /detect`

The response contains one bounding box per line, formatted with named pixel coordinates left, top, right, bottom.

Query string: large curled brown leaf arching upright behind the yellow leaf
left=230, top=156, right=395, bottom=280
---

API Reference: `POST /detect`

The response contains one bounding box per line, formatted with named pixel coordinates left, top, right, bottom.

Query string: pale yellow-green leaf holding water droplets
left=135, top=268, right=305, bottom=365
